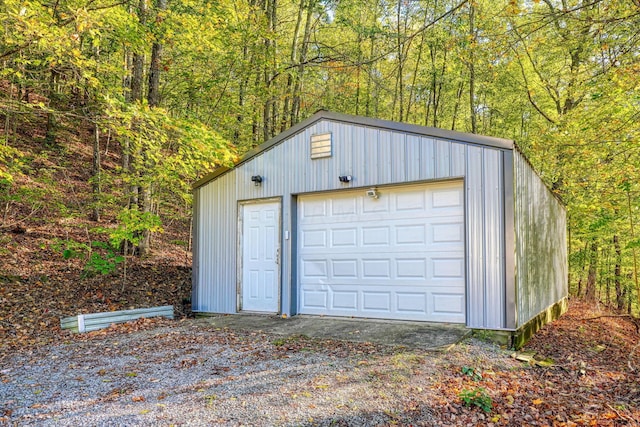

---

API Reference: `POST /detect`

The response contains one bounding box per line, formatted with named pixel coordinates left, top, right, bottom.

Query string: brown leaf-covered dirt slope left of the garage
left=0, top=102, right=191, bottom=351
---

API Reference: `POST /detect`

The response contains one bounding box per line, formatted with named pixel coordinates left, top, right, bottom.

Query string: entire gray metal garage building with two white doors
left=192, top=111, right=567, bottom=348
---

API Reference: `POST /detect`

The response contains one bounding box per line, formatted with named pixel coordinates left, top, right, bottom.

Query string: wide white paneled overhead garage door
left=298, top=181, right=465, bottom=323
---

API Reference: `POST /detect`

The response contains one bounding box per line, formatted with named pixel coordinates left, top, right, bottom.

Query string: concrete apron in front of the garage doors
left=200, top=313, right=471, bottom=351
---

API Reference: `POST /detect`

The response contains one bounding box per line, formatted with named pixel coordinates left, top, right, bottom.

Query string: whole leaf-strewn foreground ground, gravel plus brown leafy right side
left=0, top=302, right=640, bottom=426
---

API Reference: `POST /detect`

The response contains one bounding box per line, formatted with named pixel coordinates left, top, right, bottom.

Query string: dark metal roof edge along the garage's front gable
left=192, top=110, right=515, bottom=190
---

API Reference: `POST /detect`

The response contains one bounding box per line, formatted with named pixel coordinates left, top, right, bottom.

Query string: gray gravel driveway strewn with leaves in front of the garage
left=0, top=320, right=516, bottom=426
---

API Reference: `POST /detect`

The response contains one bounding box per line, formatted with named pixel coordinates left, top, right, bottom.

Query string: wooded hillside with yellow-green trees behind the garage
left=0, top=0, right=640, bottom=320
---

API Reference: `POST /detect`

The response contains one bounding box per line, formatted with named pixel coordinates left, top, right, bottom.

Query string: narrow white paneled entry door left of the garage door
left=240, top=201, right=280, bottom=313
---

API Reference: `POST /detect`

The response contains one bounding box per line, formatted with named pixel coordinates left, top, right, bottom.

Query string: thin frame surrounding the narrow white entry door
left=236, top=197, right=282, bottom=313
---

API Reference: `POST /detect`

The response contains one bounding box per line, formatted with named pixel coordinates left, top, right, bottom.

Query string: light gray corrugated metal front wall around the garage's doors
left=193, top=119, right=515, bottom=328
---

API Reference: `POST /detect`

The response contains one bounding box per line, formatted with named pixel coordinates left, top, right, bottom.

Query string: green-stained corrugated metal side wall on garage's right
left=514, top=150, right=568, bottom=327
